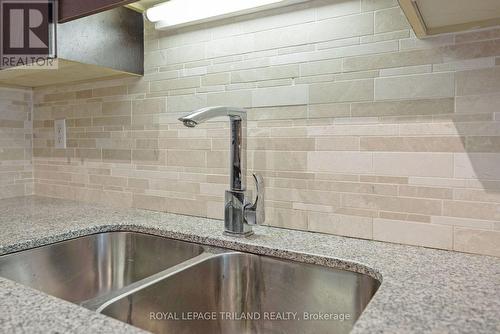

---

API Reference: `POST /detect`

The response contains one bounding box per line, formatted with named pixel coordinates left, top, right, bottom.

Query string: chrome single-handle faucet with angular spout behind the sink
left=179, top=107, right=265, bottom=237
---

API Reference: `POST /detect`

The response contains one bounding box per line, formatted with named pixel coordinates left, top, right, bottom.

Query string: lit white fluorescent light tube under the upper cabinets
left=146, top=0, right=308, bottom=29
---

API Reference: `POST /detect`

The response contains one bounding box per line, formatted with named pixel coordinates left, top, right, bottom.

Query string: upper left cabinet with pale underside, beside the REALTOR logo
left=0, top=1, right=144, bottom=87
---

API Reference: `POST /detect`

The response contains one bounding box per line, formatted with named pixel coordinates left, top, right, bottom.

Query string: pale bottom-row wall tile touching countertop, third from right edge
left=308, top=212, right=373, bottom=239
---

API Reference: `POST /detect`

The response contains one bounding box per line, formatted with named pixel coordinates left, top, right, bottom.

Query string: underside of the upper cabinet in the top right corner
left=398, top=0, right=500, bottom=38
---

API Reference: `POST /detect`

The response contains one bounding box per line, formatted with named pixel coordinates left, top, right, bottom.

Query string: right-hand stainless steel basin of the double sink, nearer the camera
left=101, top=252, right=379, bottom=333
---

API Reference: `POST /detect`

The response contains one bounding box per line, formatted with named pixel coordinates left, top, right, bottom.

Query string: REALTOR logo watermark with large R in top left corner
left=0, top=0, right=57, bottom=69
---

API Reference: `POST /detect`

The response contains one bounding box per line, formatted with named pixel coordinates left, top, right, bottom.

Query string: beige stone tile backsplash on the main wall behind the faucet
left=25, top=0, right=500, bottom=256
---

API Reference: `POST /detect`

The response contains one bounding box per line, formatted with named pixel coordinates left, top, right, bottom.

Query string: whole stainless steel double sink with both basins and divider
left=0, top=232, right=379, bottom=333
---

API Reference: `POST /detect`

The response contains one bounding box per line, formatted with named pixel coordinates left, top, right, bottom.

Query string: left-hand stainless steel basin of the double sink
left=0, top=232, right=203, bottom=303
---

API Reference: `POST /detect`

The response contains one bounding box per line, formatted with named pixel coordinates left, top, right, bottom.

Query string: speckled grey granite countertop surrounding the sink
left=0, top=196, right=500, bottom=334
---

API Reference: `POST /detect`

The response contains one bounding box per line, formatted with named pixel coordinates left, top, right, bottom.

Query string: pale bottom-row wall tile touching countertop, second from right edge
left=373, top=218, right=453, bottom=250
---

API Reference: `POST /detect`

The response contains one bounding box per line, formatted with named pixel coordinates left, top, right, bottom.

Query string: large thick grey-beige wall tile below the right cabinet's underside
left=375, top=73, right=455, bottom=100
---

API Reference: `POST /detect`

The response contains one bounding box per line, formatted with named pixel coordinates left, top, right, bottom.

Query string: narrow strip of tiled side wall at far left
left=0, top=88, right=33, bottom=199
